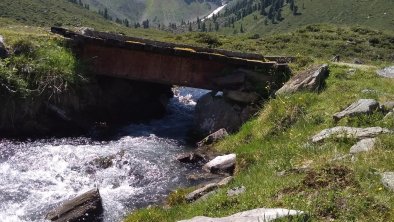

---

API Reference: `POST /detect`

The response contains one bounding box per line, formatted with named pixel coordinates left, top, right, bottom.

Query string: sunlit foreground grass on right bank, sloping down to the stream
left=125, top=64, right=394, bottom=222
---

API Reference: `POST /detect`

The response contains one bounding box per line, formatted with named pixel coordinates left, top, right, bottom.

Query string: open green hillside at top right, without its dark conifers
left=215, top=0, right=394, bottom=34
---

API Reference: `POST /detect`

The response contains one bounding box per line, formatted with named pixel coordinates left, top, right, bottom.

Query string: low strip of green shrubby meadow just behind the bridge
left=161, top=24, right=394, bottom=64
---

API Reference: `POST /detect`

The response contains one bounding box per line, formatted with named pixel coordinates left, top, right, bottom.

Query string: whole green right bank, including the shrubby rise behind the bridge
left=125, top=25, right=394, bottom=222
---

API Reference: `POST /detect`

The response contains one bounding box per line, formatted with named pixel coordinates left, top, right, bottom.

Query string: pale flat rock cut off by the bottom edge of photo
left=178, top=208, right=304, bottom=222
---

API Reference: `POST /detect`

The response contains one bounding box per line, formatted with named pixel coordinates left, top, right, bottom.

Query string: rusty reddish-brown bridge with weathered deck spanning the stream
left=51, top=27, right=290, bottom=96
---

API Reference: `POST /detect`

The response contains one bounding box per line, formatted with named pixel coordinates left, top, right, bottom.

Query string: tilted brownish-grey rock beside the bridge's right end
left=276, top=64, right=329, bottom=95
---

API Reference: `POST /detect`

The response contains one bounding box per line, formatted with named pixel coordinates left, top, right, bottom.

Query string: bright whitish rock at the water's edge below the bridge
left=203, top=154, right=237, bottom=174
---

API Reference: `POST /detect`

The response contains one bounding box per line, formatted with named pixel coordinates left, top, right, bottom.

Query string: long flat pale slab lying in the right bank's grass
left=312, top=126, right=392, bottom=143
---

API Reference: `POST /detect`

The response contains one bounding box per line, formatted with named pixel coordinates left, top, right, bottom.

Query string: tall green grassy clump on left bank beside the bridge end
left=0, top=26, right=82, bottom=97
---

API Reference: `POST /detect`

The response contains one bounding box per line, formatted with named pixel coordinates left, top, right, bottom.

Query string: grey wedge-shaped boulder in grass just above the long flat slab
left=333, top=99, right=379, bottom=121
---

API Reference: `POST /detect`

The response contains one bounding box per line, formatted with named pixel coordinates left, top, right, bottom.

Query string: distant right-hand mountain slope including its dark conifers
left=203, top=0, right=394, bottom=34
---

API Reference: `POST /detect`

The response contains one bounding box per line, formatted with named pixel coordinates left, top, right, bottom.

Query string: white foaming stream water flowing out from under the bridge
left=0, top=88, right=205, bottom=222
